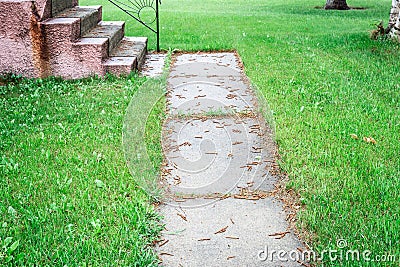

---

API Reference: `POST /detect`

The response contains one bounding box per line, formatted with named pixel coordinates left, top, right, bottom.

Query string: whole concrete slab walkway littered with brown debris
left=157, top=53, right=303, bottom=267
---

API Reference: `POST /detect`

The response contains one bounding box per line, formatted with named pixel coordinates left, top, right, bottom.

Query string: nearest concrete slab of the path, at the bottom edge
left=159, top=198, right=303, bottom=267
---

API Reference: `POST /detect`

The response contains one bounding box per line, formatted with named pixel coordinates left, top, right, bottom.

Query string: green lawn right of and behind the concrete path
left=81, top=0, right=400, bottom=266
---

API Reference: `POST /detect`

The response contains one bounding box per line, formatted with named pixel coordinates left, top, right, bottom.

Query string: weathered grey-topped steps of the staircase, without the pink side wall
left=53, top=0, right=147, bottom=76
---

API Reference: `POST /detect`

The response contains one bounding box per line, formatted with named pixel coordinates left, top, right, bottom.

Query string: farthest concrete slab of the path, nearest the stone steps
left=168, top=53, right=255, bottom=115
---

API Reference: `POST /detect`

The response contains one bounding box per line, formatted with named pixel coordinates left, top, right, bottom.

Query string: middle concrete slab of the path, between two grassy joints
left=163, top=116, right=276, bottom=195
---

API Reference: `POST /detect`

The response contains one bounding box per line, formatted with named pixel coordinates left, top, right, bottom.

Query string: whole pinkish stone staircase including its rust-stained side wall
left=0, top=0, right=147, bottom=79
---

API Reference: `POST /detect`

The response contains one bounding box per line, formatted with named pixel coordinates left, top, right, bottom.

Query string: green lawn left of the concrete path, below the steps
left=0, top=75, right=161, bottom=266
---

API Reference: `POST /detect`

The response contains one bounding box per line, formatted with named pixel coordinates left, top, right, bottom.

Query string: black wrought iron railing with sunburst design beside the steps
left=108, top=0, right=161, bottom=52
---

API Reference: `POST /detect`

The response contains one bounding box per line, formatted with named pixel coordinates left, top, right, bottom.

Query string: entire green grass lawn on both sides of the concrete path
left=0, top=0, right=400, bottom=266
